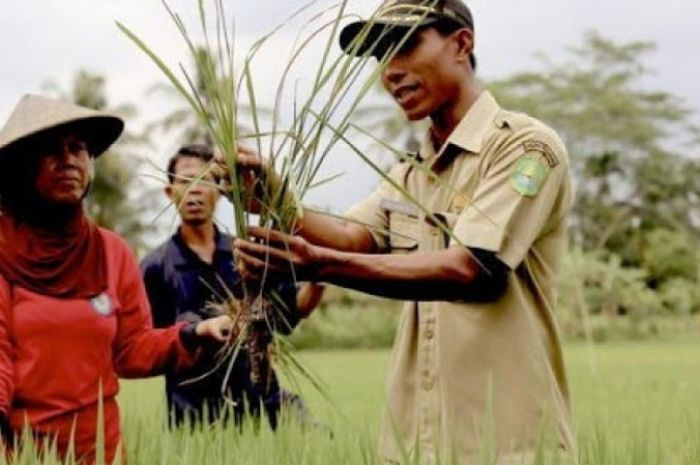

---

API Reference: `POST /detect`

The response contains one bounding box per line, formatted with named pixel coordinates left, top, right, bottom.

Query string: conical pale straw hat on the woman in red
left=0, top=95, right=124, bottom=160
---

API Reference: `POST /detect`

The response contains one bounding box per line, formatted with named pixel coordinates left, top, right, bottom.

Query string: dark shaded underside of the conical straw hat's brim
left=0, top=115, right=124, bottom=160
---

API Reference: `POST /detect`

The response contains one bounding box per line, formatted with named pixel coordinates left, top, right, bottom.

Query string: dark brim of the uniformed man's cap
left=338, top=16, right=437, bottom=58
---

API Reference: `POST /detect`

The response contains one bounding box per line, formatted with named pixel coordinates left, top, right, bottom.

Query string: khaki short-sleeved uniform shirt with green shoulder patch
left=347, top=92, right=575, bottom=464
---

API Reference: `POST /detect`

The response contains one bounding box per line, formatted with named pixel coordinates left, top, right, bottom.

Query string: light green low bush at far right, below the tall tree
left=557, top=246, right=700, bottom=340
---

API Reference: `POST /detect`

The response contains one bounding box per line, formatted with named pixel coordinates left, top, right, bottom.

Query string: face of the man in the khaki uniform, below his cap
left=382, top=27, right=465, bottom=121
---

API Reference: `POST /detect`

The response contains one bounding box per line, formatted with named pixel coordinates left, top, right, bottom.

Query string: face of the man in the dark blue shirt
left=165, top=156, right=219, bottom=225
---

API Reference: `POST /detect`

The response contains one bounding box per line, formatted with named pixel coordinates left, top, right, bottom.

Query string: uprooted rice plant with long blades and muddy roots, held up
left=117, top=0, right=442, bottom=404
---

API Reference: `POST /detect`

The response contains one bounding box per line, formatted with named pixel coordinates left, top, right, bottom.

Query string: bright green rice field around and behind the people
left=110, top=341, right=700, bottom=465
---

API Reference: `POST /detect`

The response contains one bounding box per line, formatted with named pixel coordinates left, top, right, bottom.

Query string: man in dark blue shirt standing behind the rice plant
left=141, top=144, right=317, bottom=428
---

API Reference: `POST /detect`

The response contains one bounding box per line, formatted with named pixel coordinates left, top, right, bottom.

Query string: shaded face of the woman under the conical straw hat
left=34, top=130, right=92, bottom=205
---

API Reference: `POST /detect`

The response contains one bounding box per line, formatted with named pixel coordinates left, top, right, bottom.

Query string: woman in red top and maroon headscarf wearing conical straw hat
left=0, top=92, right=230, bottom=463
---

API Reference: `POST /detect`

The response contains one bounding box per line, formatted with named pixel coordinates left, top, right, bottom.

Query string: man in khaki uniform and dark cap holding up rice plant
left=236, top=0, right=575, bottom=464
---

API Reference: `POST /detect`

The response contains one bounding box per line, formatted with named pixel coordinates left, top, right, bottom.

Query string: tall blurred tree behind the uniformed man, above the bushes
left=491, top=32, right=700, bottom=258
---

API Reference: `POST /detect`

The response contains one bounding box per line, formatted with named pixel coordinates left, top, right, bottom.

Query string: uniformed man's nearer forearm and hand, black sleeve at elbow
left=235, top=228, right=508, bottom=301
